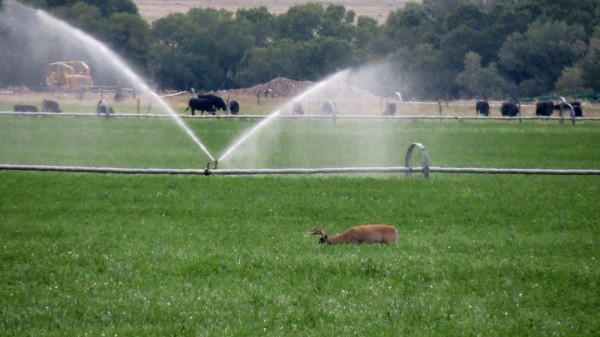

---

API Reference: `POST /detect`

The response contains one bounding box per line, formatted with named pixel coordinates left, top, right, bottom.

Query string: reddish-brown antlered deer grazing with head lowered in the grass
left=308, top=225, right=398, bottom=245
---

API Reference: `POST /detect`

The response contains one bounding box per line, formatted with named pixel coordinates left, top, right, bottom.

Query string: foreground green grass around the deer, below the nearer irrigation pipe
left=0, top=172, right=600, bottom=336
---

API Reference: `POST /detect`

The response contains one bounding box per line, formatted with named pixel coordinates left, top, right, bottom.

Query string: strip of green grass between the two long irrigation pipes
left=0, top=116, right=600, bottom=168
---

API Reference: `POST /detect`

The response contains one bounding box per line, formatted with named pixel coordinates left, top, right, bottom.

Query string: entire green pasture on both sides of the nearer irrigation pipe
left=0, top=116, right=600, bottom=336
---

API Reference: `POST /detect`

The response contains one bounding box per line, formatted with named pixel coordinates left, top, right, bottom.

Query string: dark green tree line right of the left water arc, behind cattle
left=0, top=0, right=600, bottom=99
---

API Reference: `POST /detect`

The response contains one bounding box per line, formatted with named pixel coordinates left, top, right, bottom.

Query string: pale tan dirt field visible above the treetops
left=133, top=0, right=412, bottom=22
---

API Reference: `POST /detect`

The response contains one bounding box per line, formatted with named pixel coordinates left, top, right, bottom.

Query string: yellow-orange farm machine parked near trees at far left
left=46, top=61, right=94, bottom=89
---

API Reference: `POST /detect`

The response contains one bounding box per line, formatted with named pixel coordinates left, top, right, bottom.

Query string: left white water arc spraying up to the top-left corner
left=4, top=1, right=215, bottom=161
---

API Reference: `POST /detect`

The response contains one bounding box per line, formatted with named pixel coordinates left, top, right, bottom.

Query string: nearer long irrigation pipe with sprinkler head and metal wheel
left=0, top=143, right=600, bottom=179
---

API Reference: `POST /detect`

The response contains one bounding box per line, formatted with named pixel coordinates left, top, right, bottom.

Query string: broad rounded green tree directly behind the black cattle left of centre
left=151, top=8, right=256, bottom=90
